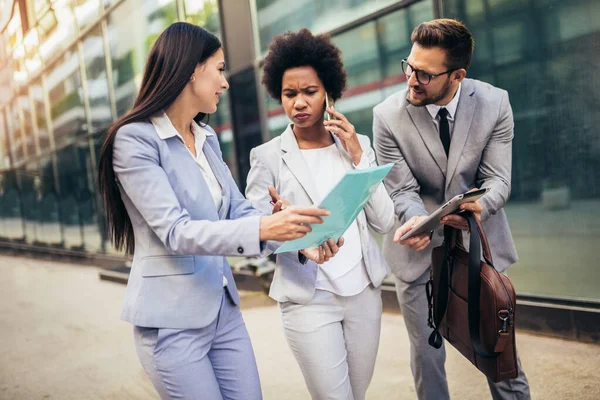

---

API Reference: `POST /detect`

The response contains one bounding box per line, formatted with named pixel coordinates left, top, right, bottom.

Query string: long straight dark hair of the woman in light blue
left=98, top=22, right=221, bottom=254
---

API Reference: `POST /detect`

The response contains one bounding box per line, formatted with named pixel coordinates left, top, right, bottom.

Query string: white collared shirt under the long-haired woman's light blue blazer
left=150, top=112, right=227, bottom=286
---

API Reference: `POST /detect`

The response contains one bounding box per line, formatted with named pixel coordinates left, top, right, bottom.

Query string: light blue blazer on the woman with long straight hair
left=113, top=122, right=261, bottom=329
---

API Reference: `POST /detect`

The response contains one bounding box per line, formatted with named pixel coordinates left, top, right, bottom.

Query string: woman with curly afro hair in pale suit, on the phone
left=246, top=29, right=394, bottom=400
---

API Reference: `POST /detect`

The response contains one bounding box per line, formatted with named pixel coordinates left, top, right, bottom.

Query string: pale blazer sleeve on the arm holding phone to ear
left=355, top=136, right=394, bottom=234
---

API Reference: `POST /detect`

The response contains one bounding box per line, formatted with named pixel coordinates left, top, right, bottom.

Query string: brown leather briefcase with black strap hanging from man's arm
left=426, top=212, right=518, bottom=382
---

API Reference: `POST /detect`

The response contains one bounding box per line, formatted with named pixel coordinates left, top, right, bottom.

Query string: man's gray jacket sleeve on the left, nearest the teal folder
left=373, top=108, right=429, bottom=223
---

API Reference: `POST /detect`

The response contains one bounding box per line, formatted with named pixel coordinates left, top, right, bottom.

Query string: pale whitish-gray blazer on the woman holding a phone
left=246, top=126, right=394, bottom=304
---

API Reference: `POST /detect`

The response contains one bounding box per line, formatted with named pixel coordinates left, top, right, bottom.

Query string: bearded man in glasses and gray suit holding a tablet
left=373, top=19, right=530, bottom=400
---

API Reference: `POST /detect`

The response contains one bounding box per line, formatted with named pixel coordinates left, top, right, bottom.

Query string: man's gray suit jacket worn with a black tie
left=373, top=79, right=517, bottom=282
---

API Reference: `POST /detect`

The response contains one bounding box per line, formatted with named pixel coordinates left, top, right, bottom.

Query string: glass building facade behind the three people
left=0, top=0, right=600, bottom=300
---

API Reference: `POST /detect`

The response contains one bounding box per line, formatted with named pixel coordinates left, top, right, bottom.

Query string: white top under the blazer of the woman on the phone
left=300, top=143, right=371, bottom=296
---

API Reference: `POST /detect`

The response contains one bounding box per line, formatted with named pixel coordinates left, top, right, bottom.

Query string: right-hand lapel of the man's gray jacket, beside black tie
left=446, top=79, right=477, bottom=189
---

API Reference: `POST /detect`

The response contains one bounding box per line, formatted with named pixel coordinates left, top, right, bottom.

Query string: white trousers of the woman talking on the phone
left=280, top=285, right=382, bottom=400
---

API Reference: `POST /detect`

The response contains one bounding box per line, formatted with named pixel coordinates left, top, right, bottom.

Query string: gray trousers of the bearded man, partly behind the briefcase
left=396, top=269, right=531, bottom=400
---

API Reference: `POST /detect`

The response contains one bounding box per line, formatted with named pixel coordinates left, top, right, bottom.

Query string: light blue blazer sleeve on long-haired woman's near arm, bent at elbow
left=113, top=124, right=261, bottom=256
